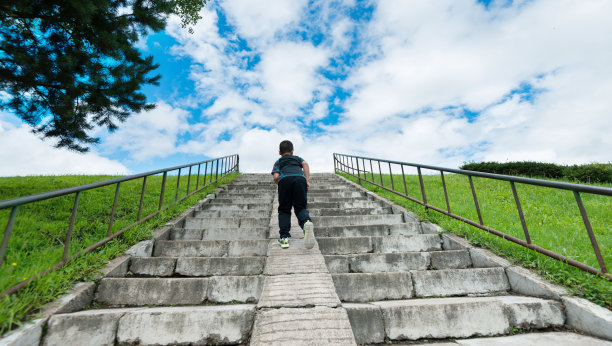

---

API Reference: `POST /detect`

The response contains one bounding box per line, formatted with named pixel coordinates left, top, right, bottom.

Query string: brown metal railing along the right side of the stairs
left=333, top=153, right=612, bottom=280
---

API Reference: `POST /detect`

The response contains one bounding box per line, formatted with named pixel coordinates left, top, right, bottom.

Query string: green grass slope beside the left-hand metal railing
left=0, top=174, right=237, bottom=334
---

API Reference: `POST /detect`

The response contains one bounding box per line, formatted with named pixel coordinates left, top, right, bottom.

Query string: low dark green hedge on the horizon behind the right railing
left=460, top=161, right=612, bottom=183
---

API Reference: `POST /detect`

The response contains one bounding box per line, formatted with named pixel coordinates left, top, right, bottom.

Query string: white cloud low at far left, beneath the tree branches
left=0, top=113, right=128, bottom=176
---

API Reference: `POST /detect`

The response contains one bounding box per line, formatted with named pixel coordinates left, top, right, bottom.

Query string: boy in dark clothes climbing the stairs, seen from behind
left=272, top=141, right=314, bottom=249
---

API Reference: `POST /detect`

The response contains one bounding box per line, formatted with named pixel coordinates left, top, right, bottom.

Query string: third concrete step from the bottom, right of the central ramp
left=324, top=250, right=474, bottom=273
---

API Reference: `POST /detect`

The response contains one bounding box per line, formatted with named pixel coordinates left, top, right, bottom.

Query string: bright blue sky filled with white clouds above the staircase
left=0, top=0, right=612, bottom=175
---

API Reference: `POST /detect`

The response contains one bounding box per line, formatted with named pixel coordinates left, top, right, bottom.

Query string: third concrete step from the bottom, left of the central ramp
left=129, top=256, right=266, bottom=277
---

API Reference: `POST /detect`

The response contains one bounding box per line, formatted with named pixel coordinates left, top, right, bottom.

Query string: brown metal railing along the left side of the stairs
left=0, top=154, right=240, bottom=297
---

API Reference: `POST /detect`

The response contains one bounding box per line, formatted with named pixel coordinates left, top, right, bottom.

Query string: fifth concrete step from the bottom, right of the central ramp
left=315, top=222, right=421, bottom=237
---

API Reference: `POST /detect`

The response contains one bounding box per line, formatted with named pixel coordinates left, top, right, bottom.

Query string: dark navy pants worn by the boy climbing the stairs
left=278, top=176, right=310, bottom=238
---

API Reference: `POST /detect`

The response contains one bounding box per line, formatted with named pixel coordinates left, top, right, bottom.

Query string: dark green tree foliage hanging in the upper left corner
left=0, top=0, right=206, bottom=151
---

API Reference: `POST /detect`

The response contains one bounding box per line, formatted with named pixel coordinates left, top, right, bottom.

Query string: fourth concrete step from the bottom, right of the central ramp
left=317, top=234, right=440, bottom=254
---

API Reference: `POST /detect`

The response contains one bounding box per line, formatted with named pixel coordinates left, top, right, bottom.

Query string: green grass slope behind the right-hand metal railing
left=341, top=168, right=612, bottom=309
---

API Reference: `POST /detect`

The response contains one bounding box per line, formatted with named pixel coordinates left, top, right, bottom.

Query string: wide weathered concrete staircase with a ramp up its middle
left=34, top=174, right=610, bottom=345
